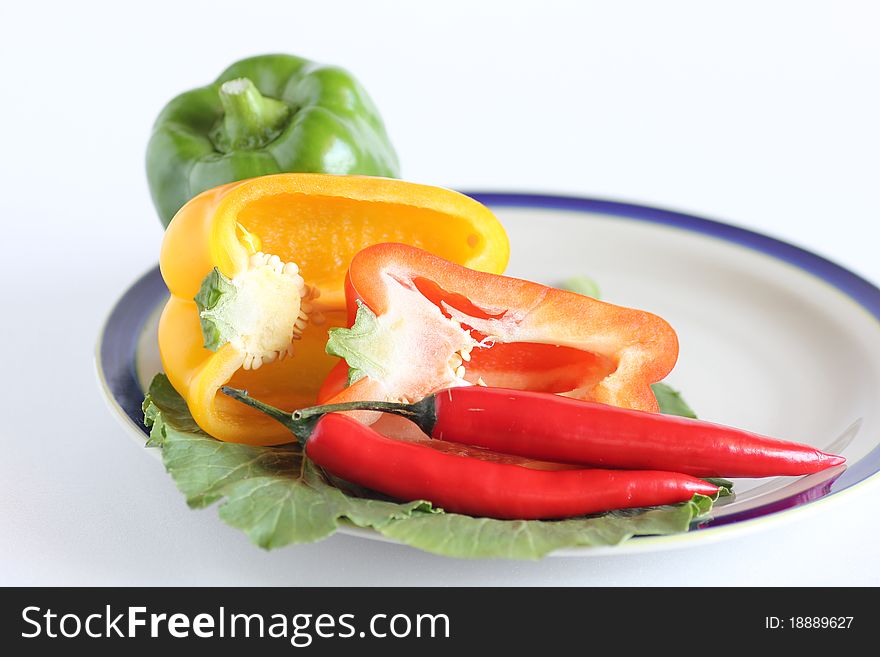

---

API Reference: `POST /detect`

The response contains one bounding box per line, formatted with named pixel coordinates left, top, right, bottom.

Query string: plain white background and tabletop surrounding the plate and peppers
left=0, top=0, right=880, bottom=585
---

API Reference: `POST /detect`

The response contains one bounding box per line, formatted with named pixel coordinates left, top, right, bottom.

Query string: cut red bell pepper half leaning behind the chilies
left=319, top=244, right=678, bottom=420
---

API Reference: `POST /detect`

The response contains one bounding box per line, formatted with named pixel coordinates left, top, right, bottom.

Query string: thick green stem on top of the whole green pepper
left=219, top=78, right=290, bottom=150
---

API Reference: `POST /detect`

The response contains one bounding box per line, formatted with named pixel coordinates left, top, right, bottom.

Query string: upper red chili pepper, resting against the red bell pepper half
left=284, top=386, right=846, bottom=477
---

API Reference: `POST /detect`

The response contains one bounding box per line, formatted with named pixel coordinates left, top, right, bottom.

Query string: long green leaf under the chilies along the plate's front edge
left=144, top=374, right=729, bottom=559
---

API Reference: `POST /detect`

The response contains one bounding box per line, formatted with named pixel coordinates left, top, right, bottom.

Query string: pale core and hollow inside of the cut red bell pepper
left=327, top=281, right=616, bottom=403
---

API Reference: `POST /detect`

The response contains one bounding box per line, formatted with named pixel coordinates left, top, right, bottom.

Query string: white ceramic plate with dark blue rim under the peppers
left=98, top=193, right=880, bottom=555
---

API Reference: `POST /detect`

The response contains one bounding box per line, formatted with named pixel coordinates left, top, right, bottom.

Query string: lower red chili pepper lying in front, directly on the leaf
left=222, top=387, right=718, bottom=520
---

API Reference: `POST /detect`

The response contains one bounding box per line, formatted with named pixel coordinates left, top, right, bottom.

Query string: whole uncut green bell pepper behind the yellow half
left=147, top=55, right=398, bottom=226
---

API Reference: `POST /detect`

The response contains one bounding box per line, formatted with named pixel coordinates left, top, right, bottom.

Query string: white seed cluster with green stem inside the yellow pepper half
left=195, top=251, right=322, bottom=370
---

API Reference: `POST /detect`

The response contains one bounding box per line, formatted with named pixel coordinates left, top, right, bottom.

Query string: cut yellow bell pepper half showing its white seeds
left=159, top=173, right=509, bottom=445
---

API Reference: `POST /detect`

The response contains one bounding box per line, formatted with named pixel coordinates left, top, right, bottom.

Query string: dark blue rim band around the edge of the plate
left=96, top=191, right=880, bottom=530
